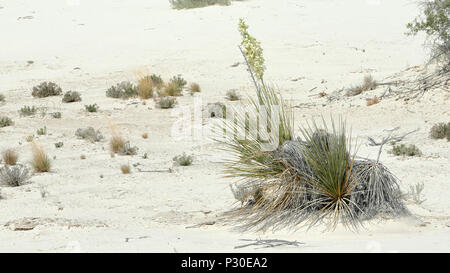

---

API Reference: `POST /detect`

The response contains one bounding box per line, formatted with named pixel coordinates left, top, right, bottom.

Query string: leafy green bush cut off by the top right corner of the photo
left=407, top=0, right=450, bottom=69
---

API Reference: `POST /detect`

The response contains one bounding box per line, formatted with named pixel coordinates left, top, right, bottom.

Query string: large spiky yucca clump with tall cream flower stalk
left=216, top=20, right=409, bottom=230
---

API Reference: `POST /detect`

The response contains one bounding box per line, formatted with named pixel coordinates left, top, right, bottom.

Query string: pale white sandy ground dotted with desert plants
left=0, top=0, right=450, bottom=252
